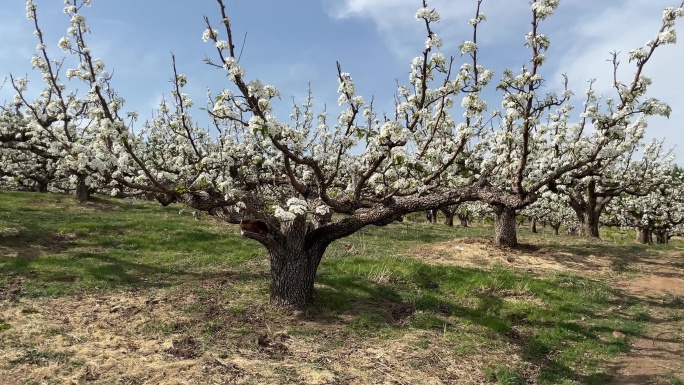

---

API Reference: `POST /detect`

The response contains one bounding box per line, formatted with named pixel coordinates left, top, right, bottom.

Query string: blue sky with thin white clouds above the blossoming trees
left=0, top=0, right=684, bottom=160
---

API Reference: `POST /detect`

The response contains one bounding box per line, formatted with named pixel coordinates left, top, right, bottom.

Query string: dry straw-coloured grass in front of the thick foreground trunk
left=0, top=280, right=522, bottom=385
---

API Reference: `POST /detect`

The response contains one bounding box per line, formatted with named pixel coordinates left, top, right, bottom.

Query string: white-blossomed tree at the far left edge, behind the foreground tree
left=2, top=1, right=120, bottom=201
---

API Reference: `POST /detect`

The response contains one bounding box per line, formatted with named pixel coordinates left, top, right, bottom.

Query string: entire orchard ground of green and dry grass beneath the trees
left=0, top=192, right=684, bottom=385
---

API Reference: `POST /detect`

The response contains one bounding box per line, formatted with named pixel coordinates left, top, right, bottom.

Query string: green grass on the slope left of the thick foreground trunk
left=0, top=192, right=264, bottom=296
